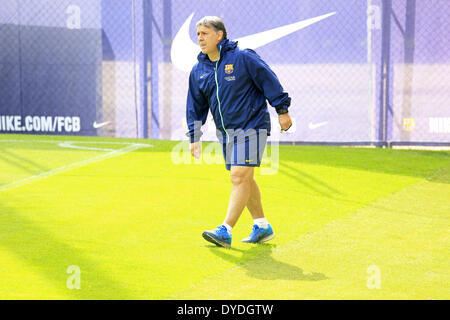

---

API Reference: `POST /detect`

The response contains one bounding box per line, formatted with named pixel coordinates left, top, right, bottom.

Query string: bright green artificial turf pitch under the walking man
left=0, top=135, right=450, bottom=299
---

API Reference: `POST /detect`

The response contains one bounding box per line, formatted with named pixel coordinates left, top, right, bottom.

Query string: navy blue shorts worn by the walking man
left=222, top=130, right=267, bottom=170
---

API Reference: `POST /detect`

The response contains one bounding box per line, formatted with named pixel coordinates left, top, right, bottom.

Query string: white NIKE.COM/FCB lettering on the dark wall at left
left=0, top=115, right=81, bottom=132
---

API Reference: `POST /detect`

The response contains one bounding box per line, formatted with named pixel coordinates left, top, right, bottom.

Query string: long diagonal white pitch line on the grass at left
left=0, top=140, right=153, bottom=192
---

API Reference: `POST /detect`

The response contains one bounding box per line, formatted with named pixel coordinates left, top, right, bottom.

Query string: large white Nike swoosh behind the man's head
left=170, top=12, right=336, bottom=72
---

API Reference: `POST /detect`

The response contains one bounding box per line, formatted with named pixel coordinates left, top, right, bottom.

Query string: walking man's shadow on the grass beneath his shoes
left=208, top=244, right=328, bottom=281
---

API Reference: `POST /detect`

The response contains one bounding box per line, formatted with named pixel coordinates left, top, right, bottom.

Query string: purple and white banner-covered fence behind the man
left=0, top=0, right=450, bottom=145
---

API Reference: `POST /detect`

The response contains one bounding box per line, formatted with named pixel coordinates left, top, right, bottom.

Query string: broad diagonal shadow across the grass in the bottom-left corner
left=0, top=204, right=133, bottom=300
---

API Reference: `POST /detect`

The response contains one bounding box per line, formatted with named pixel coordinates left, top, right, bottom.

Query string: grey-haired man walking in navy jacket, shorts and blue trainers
left=186, top=16, right=292, bottom=247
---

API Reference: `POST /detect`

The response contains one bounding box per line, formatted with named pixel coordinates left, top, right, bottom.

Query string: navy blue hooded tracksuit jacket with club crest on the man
left=186, top=39, right=291, bottom=143
